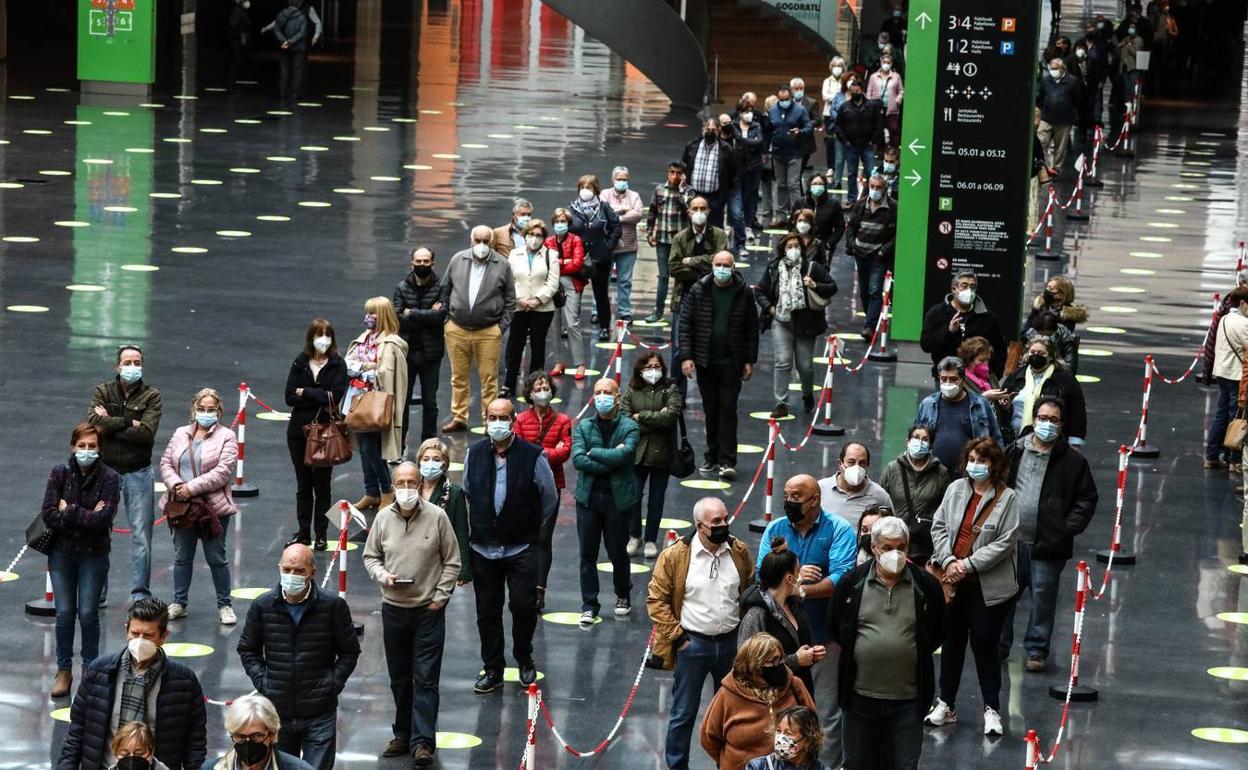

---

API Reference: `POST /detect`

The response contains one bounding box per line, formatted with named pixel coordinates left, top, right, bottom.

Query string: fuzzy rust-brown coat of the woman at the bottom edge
left=701, top=671, right=815, bottom=770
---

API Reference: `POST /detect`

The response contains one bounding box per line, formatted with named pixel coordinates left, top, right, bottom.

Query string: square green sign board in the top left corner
left=77, top=0, right=156, bottom=84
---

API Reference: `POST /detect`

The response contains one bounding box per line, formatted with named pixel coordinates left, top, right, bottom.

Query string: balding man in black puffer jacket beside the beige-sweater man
left=238, top=543, right=359, bottom=770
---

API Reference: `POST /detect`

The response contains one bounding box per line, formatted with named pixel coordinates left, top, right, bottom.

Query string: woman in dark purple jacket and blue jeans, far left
left=40, top=423, right=121, bottom=698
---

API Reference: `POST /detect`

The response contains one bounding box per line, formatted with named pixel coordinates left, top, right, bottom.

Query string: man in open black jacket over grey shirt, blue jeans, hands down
left=1001, top=396, right=1098, bottom=673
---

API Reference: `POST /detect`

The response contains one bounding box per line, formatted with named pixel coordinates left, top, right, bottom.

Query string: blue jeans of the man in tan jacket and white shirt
left=664, top=630, right=736, bottom=770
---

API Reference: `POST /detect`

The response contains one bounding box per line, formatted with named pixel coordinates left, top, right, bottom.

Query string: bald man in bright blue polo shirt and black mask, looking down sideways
left=758, top=474, right=857, bottom=768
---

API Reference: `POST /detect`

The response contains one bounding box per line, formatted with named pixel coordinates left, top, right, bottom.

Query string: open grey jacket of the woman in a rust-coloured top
left=932, top=478, right=1018, bottom=607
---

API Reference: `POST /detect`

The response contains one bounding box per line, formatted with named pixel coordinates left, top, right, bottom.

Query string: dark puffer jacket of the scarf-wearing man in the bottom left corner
left=56, top=651, right=207, bottom=770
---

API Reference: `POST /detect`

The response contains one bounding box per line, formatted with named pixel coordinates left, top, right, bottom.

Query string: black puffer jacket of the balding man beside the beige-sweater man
left=238, top=584, right=359, bottom=719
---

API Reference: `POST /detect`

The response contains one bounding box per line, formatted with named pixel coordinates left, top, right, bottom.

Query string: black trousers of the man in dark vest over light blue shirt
left=472, top=545, right=538, bottom=674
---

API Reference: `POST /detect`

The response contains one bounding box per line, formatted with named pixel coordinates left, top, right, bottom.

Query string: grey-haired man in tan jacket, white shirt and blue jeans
left=645, top=497, right=753, bottom=770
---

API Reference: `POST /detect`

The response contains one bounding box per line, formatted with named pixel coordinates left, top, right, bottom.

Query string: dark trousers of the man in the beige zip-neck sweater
left=382, top=603, right=449, bottom=751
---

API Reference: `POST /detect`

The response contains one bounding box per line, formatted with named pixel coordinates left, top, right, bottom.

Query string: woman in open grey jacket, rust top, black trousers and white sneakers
left=924, top=438, right=1018, bottom=738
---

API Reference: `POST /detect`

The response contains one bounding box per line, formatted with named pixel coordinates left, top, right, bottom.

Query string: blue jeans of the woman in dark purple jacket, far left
left=47, top=549, right=109, bottom=671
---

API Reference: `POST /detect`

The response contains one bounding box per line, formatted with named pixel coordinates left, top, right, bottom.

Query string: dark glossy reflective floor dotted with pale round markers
left=0, top=1, right=1248, bottom=769
